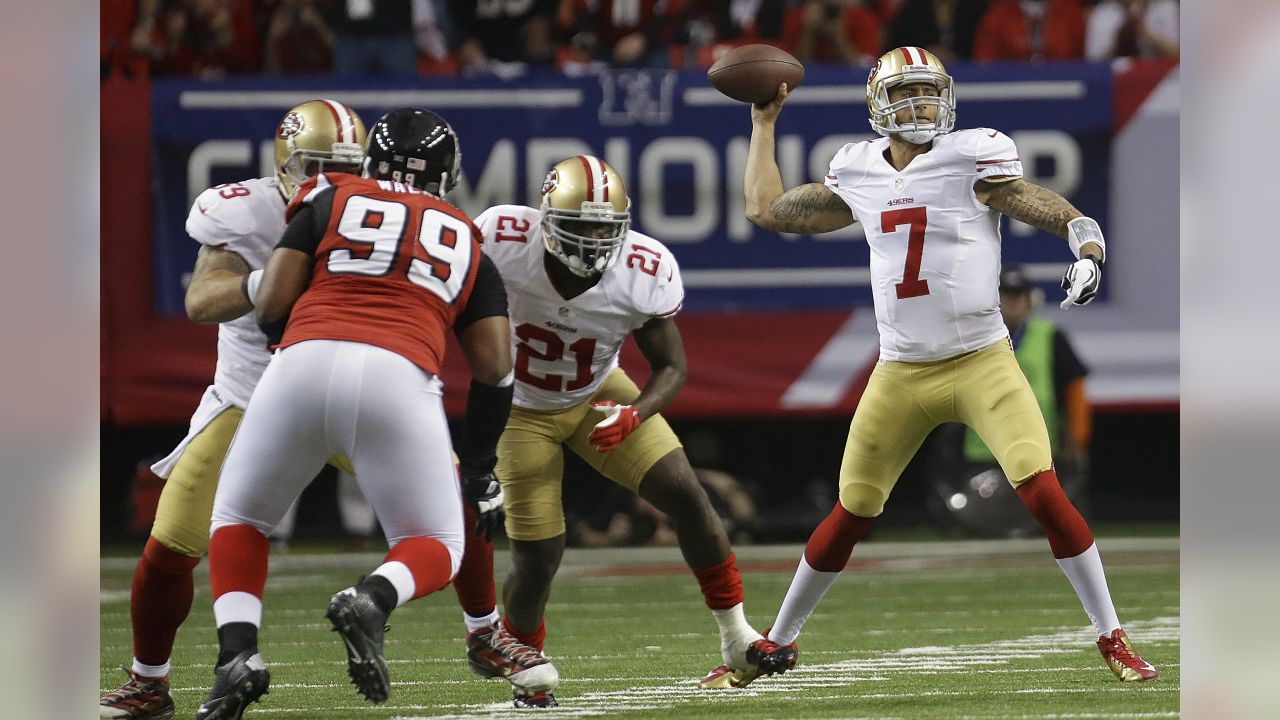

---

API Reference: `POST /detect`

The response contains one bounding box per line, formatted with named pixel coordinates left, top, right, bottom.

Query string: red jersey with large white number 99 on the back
left=278, top=173, right=481, bottom=374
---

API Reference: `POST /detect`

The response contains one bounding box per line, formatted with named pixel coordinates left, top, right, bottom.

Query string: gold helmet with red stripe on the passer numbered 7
left=867, top=47, right=956, bottom=145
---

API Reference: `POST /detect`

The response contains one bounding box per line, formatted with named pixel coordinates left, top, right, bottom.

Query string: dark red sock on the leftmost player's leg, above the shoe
left=129, top=538, right=200, bottom=665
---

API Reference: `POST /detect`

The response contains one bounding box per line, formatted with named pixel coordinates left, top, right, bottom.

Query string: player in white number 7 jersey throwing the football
left=706, top=47, right=1158, bottom=687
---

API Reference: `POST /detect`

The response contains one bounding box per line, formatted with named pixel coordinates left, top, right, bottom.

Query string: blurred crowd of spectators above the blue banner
left=101, top=0, right=1179, bottom=78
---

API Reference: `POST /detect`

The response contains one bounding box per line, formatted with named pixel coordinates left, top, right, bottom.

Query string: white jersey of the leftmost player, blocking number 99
left=187, top=177, right=284, bottom=407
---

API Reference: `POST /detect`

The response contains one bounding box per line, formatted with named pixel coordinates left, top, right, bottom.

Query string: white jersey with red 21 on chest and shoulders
left=476, top=205, right=685, bottom=410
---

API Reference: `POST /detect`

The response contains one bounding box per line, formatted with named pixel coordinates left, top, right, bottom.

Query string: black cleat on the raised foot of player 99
left=324, top=588, right=390, bottom=702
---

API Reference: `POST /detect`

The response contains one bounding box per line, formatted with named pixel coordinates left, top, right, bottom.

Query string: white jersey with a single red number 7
left=826, top=128, right=1023, bottom=363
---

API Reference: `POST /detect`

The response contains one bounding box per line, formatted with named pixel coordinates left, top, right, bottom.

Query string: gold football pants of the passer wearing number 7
left=840, top=340, right=1053, bottom=518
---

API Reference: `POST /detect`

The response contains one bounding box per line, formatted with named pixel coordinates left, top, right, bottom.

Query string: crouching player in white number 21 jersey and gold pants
left=476, top=155, right=795, bottom=707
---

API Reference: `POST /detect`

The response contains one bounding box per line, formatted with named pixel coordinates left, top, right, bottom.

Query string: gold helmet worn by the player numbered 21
left=541, top=155, right=631, bottom=278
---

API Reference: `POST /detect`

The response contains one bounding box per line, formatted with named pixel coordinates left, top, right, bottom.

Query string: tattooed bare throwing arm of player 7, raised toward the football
left=742, top=83, right=854, bottom=233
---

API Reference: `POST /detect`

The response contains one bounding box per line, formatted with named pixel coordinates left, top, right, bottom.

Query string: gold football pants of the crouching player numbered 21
left=497, top=369, right=681, bottom=542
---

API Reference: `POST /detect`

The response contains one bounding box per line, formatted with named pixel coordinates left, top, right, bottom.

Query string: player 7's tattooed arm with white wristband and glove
left=974, top=178, right=1106, bottom=309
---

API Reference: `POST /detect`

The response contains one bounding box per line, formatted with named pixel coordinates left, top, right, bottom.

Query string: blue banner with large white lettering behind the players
left=152, top=64, right=1112, bottom=315
